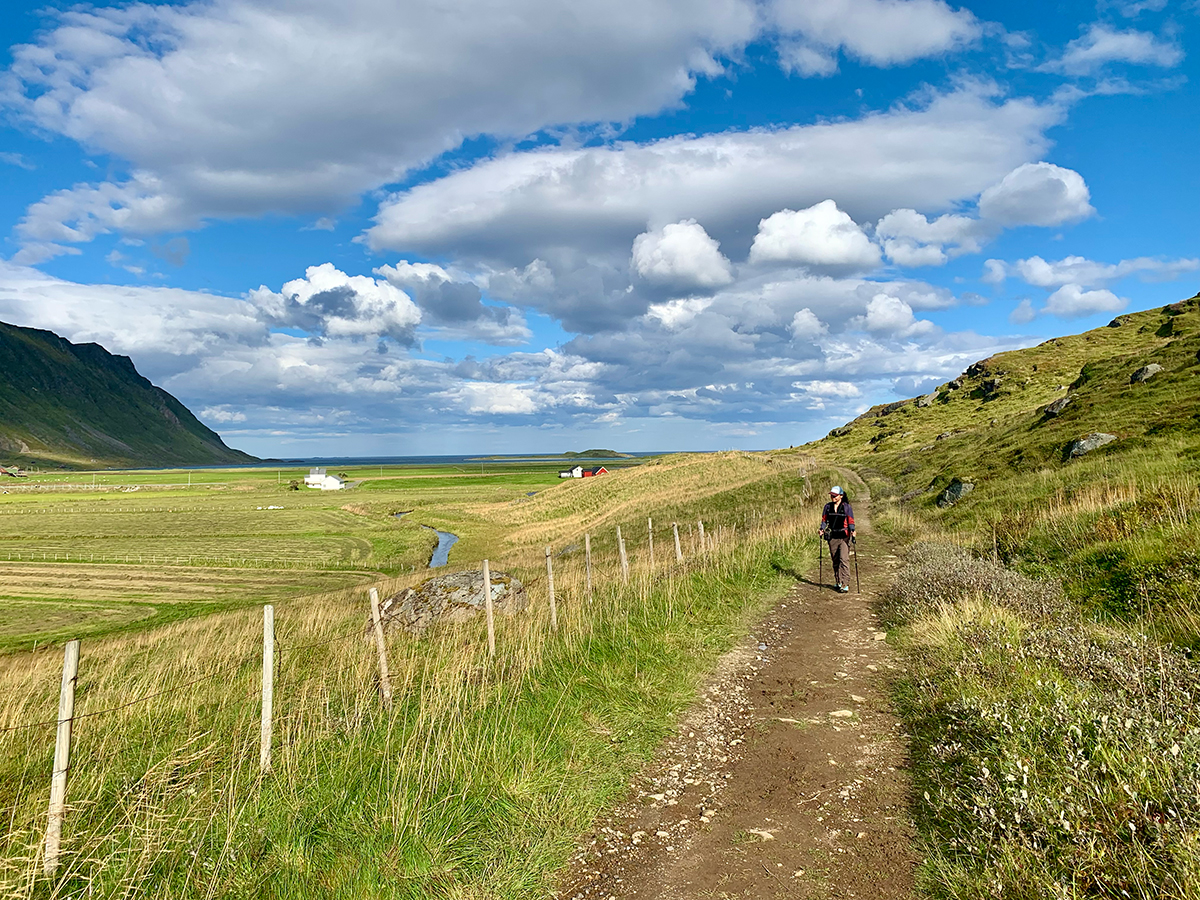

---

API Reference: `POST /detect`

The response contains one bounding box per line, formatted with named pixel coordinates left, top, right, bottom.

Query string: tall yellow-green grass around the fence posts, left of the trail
left=0, top=508, right=812, bottom=898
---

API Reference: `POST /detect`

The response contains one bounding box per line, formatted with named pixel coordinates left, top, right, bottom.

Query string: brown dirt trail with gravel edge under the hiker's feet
left=558, top=504, right=917, bottom=900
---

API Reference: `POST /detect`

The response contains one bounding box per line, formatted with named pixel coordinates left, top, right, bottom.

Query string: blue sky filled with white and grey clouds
left=0, top=0, right=1200, bottom=456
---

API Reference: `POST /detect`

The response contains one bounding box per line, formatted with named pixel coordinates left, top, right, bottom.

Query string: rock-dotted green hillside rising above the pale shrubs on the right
left=821, top=295, right=1200, bottom=648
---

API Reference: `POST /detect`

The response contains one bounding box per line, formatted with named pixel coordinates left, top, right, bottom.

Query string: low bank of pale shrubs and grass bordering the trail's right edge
left=884, top=544, right=1200, bottom=899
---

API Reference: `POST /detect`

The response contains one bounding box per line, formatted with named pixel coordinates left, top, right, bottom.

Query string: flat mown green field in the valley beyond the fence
left=0, top=461, right=633, bottom=649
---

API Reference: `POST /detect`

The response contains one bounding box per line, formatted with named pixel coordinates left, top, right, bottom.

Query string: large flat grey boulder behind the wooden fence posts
left=366, top=569, right=529, bottom=636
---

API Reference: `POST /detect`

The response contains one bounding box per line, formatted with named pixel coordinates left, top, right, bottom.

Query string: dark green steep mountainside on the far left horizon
left=0, top=323, right=254, bottom=468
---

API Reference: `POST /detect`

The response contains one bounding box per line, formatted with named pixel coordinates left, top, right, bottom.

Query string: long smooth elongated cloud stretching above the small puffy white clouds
left=367, top=86, right=1062, bottom=268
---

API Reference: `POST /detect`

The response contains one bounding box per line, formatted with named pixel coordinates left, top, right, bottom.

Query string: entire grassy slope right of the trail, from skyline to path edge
left=805, top=295, right=1200, bottom=899
